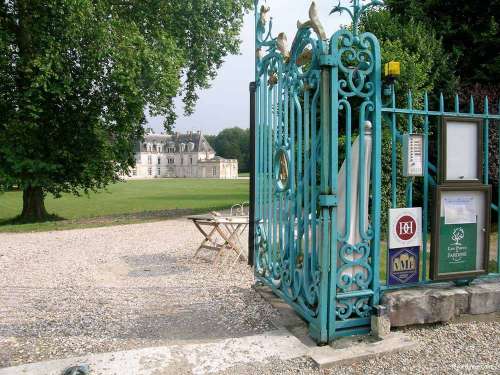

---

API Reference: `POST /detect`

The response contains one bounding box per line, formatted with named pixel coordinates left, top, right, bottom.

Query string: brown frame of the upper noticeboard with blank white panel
left=438, top=116, right=483, bottom=185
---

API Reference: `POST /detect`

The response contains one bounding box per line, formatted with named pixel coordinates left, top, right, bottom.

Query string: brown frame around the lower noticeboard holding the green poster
left=430, top=184, right=491, bottom=281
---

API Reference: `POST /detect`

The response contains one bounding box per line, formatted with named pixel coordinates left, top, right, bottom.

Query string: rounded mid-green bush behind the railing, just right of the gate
left=361, top=9, right=458, bottom=225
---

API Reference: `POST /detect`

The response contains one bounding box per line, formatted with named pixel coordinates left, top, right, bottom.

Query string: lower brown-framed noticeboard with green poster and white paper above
left=431, top=184, right=491, bottom=280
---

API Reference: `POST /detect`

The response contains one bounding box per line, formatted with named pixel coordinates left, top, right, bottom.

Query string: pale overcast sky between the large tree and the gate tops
left=149, top=0, right=349, bottom=134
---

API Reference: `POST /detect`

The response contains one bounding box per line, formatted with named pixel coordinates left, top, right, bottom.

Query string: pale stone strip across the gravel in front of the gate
left=0, top=330, right=308, bottom=375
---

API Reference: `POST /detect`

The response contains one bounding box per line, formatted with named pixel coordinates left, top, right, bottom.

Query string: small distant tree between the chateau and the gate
left=207, top=127, right=250, bottom=172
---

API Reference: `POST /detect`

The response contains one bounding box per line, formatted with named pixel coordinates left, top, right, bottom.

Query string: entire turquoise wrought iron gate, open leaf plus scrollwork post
left=254, top=0, right=381, bottom=342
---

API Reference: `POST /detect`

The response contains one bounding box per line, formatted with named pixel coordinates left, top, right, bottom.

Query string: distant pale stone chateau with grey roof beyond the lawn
left=126, top=129, right=238, bottom=179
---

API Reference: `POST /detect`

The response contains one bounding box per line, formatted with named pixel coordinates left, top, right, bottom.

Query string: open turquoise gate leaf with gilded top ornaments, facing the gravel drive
left=255, top=2, right=323, bottom=321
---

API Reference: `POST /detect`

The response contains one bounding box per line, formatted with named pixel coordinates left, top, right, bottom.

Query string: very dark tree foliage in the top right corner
left=385, top=0, right=500, bottom=85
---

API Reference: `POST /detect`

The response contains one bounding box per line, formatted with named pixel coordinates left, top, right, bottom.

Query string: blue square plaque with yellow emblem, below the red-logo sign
left=387, top=246, right=420, bottom=285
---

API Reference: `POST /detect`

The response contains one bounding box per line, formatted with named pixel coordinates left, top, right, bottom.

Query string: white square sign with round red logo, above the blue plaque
left=389, top=207, right=422, bottom=249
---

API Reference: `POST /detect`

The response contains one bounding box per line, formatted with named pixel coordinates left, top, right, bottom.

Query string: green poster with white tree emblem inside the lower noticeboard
left=439, top=217, right=477, bottom=273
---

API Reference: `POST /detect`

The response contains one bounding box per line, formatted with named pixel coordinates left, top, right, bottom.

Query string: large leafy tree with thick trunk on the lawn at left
left=0, top=0, right=251, bottom=220
